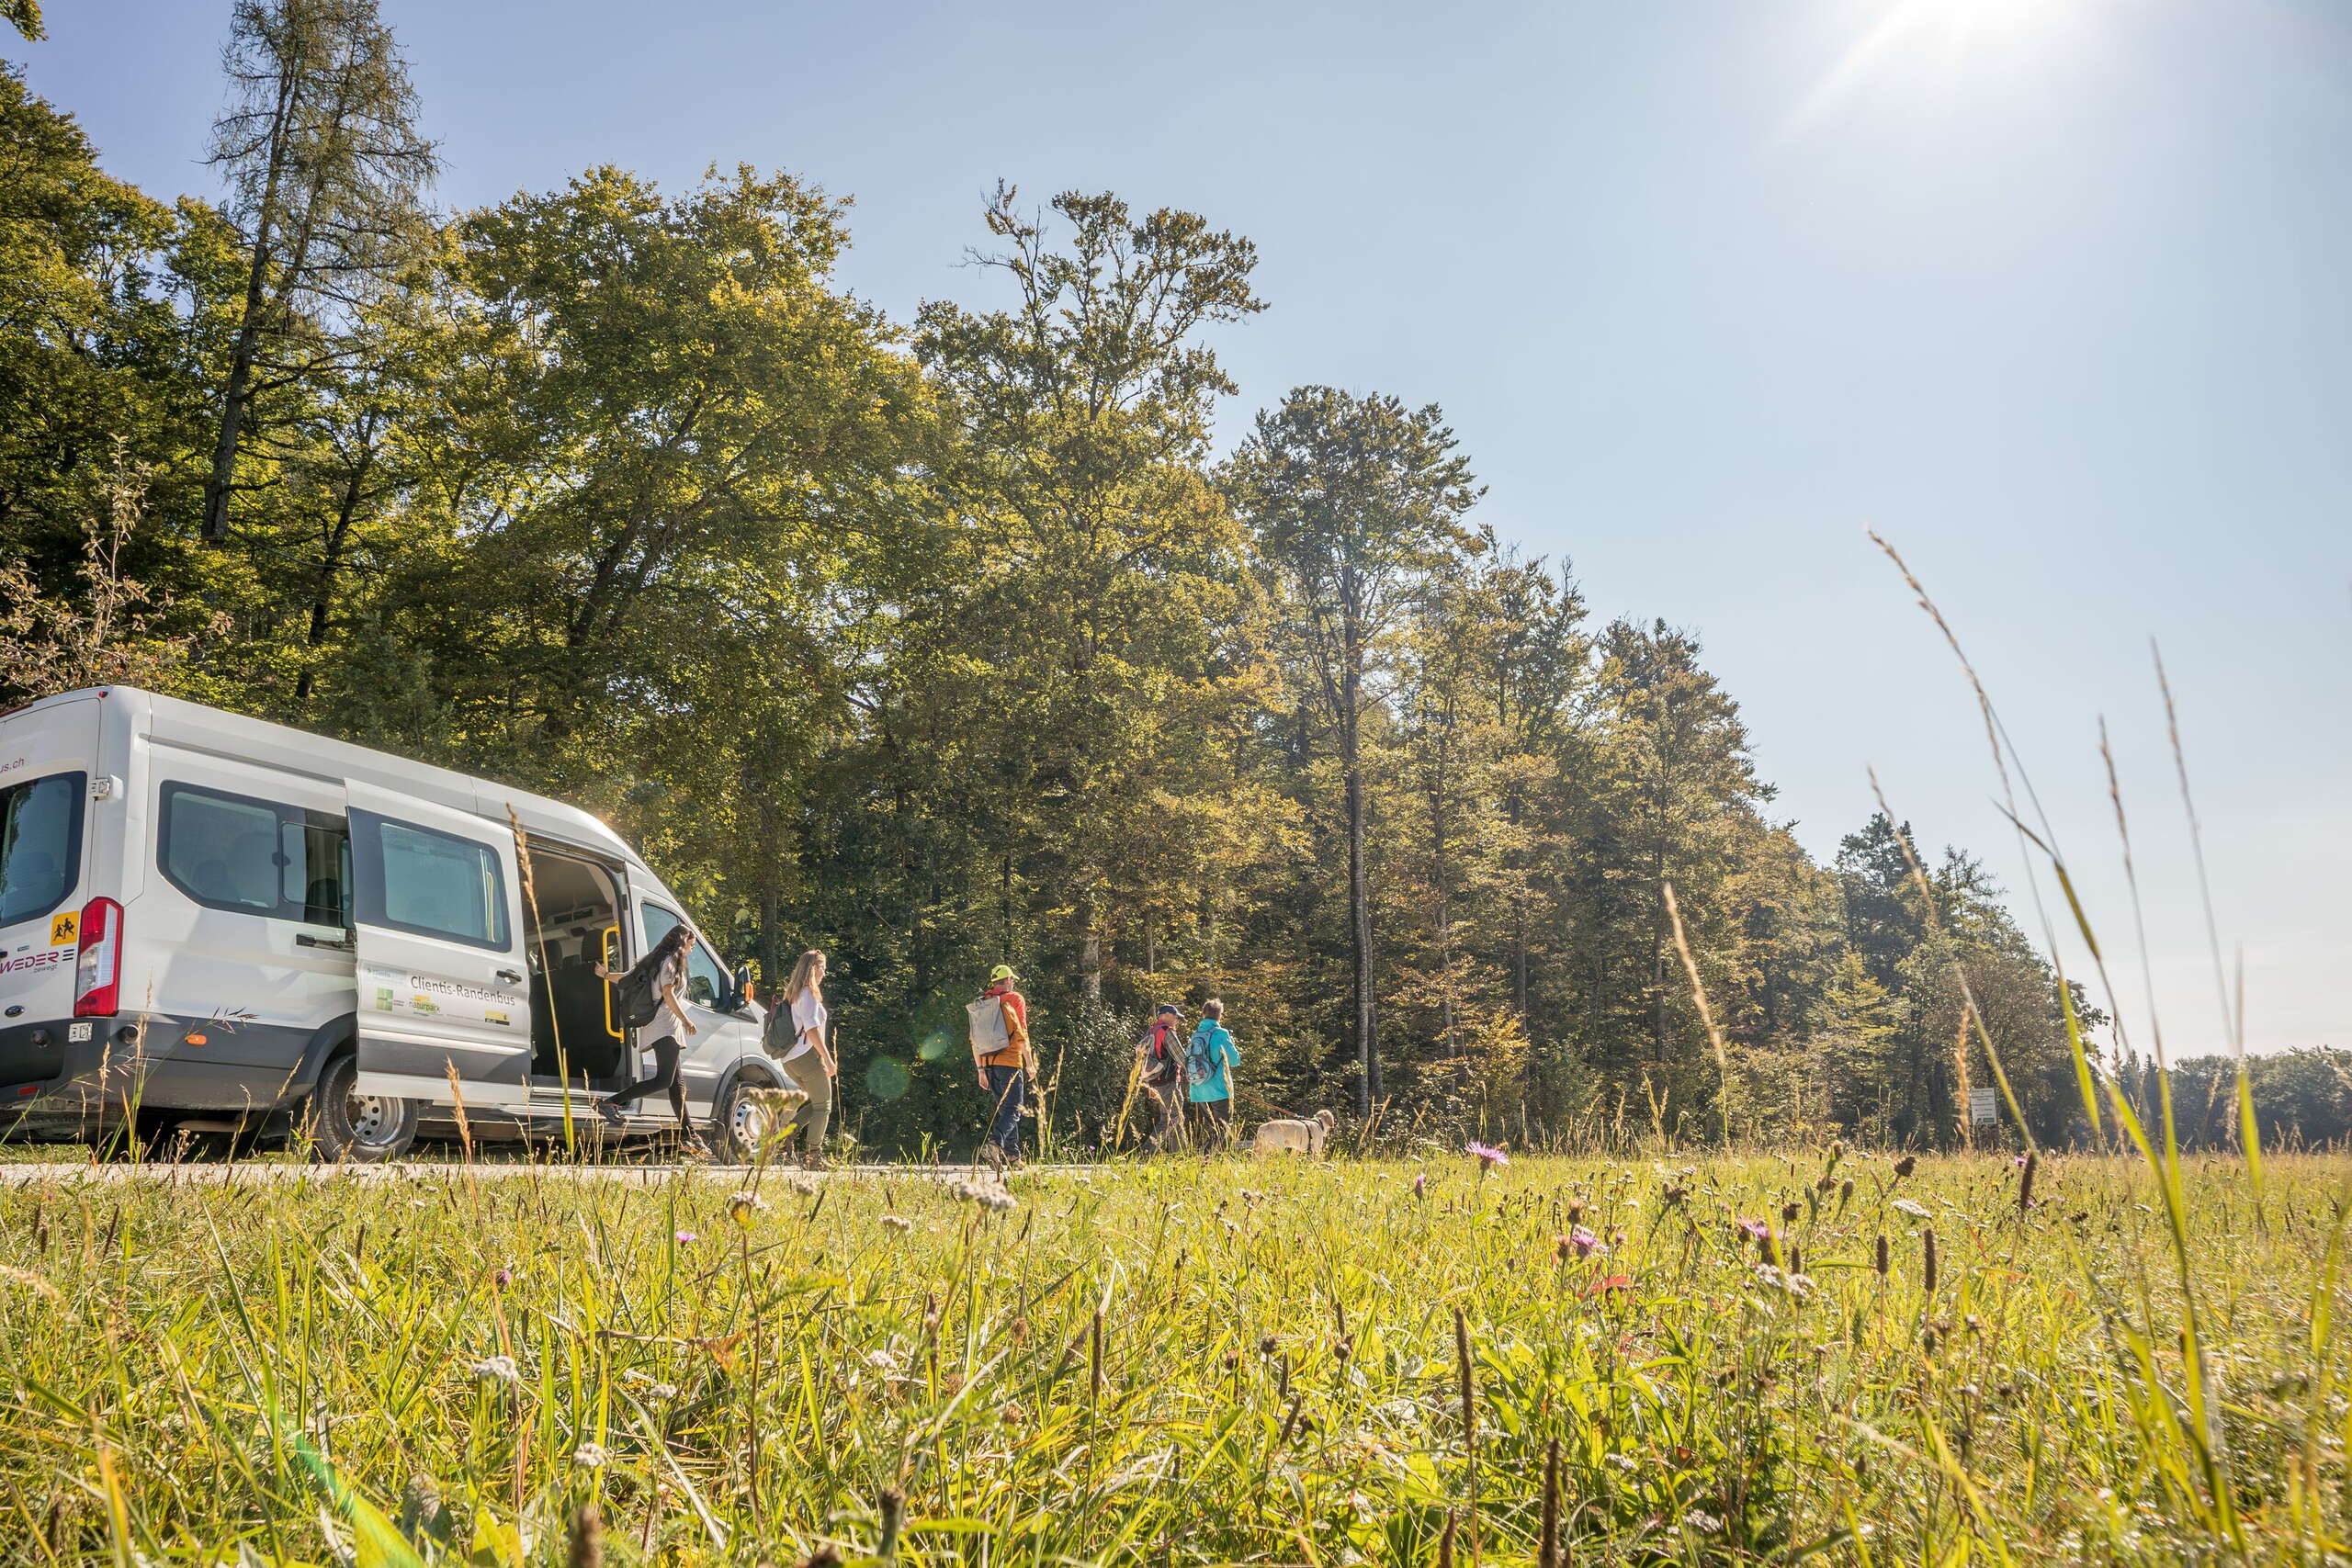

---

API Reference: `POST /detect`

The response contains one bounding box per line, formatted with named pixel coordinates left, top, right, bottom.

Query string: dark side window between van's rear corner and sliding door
left=155, top=781, right=350, bottom=926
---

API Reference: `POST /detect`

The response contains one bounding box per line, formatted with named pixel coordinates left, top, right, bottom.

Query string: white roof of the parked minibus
left=22, top=686, right=651, bottom=870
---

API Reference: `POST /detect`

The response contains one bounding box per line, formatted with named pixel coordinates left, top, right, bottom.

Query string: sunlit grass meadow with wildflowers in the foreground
left=0, top=1149, right=2352, bottom=1568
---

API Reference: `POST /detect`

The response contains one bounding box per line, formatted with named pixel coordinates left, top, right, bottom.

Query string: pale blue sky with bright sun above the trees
left=14, top=0, right=2352, bottom=1051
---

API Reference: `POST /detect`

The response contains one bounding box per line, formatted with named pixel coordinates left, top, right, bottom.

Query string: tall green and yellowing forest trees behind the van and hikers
left=0, top=17, right=2135, bottom=1149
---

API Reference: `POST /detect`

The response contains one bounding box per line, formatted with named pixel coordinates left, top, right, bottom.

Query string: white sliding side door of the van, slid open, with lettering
left=350, top=781, right=532, bottom=1107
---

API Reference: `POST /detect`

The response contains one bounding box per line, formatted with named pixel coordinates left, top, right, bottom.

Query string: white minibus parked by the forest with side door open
left=0, top=686, right=788, bottom=1161
